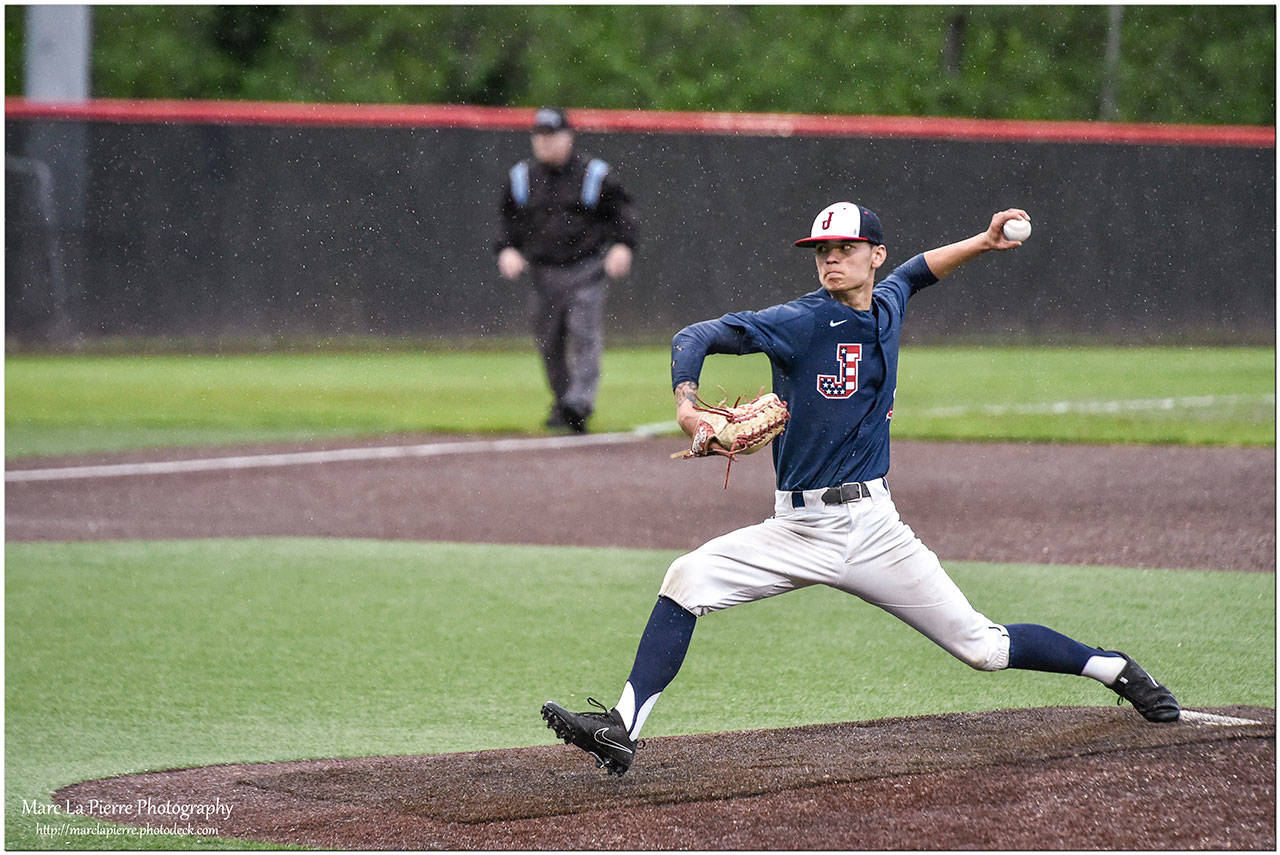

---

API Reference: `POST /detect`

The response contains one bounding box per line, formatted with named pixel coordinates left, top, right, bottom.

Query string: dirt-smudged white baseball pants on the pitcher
left=660, top=479, right=1009, bottom=671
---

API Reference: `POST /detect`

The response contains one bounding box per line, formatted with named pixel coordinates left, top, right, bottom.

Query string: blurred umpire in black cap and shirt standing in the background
left=494, top=108, right=636, bottom=434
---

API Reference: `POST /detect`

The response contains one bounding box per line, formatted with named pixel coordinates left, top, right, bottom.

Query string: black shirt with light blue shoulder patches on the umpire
left=494, top=152, right=636, bottom=265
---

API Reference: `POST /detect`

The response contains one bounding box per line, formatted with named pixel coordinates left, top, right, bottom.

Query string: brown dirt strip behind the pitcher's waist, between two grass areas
left=5, top=436, right=1276, bottom=572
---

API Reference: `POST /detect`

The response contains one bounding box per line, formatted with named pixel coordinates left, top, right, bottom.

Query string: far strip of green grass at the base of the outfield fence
left=5, top=348, right=1275, bottom=459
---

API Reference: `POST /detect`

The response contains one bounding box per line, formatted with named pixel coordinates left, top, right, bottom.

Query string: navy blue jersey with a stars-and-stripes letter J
left=671, top=255, right=937, bottom=490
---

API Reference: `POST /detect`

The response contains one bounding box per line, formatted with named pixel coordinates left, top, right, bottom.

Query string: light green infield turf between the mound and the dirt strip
left=5, top=539, right=1275, bottom=849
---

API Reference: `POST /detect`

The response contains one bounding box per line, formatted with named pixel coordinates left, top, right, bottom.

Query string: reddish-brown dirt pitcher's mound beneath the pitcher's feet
left=54, top=707, right=1276, bottom=850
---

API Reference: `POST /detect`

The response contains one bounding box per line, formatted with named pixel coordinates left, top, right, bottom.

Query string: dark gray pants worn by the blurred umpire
left=530, top=256, right=608, bottom=416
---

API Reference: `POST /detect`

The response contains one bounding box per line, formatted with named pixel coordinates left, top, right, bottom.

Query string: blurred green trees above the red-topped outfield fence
left=5, top=5, right=1276, bottom=124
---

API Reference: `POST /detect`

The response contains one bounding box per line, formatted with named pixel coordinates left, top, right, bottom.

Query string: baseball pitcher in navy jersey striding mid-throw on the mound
left=543, top=202, right=1180, bottom=774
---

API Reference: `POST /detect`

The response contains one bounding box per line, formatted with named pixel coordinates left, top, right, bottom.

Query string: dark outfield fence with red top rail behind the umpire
left=5, top=99, right=1276, bottom=346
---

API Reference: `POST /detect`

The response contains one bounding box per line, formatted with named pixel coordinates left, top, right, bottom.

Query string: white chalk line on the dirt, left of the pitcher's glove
left=4, top=425, right=666, bottom=484
